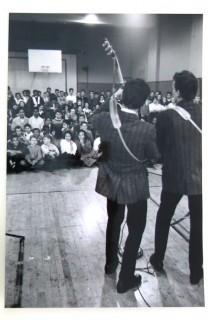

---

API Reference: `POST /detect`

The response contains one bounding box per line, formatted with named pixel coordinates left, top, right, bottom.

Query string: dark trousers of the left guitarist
left=106, top=199, right=147, bottom=282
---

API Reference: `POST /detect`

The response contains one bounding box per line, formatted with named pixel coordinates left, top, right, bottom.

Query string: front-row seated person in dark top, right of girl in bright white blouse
left=75, top=130, right=97, bottom=167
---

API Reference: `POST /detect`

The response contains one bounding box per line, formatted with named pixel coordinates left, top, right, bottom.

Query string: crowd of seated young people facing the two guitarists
left=7, top=87, right=200, bottom=172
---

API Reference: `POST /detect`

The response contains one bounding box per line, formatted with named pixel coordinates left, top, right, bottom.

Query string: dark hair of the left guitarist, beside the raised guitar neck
left=123, top=79, right=150, bottom=109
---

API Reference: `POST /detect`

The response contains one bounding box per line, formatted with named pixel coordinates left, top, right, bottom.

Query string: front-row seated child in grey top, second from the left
left=25, top=136, right=44, bottom=169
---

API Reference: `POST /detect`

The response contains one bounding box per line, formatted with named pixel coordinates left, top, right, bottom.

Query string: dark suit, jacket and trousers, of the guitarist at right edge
left=154, top=101, right=203, bottom=278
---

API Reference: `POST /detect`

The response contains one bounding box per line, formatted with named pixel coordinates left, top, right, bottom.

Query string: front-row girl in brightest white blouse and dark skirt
left=60, top=131, right=81, bottom=167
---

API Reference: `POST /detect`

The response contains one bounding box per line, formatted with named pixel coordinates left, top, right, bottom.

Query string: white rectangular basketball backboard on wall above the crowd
left=28, top=49, right=62, bottom=73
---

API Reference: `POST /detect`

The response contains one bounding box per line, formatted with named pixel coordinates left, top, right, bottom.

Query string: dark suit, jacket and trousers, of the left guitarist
left=92, top=104, right=159, bottom=283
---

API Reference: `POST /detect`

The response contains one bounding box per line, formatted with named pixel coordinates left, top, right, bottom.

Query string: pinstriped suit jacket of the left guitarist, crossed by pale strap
left=92, top=107, right=159, bottom=204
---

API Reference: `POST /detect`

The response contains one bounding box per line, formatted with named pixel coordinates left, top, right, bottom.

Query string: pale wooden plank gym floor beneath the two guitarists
left=5, top=168, right=204, bottom=308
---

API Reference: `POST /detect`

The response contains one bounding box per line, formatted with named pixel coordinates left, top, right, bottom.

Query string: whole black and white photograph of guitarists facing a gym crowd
left=0, top=1, right=205, bottom=316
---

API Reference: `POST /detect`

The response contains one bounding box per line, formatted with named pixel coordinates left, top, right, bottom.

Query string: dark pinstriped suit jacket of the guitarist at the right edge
left=156, top=101, right=202, bottom=195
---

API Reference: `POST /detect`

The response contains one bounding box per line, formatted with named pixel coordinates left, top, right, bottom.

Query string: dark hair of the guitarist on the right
left=173, top=70, right=198, bottom=100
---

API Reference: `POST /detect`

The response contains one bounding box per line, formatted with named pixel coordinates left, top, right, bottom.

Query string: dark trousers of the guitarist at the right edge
left=155, top=191, right=203, bottom=275
